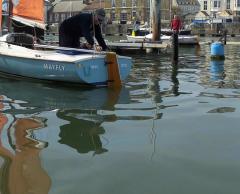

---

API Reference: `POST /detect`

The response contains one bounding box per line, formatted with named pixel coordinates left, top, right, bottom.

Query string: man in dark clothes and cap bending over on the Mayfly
left=59, top=9, right=107, bottom=51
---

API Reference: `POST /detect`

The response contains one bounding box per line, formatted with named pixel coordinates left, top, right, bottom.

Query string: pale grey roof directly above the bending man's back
left=53, top=0, right=86, bottom=13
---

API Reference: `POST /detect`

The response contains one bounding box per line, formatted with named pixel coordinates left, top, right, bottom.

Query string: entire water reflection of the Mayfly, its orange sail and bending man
left=0, top=78, right=129, bottom=194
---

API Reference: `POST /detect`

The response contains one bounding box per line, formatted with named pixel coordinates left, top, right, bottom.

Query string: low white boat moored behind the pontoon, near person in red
left=127, top=34, right=199, bottom=45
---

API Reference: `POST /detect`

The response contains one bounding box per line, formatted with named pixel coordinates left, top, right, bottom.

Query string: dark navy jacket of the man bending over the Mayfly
left=59, top=13, right=107, bottom=50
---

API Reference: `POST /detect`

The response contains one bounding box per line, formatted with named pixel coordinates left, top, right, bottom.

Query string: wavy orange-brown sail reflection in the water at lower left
left=0, top=95, right=51, bottom=194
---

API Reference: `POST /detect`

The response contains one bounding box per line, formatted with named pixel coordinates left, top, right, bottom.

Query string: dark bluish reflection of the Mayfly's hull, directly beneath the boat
left=0, top=78, right=129, bottom=114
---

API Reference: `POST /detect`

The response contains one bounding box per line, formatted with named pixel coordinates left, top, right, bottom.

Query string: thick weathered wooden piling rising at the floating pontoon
left=151, top=0, right=161, bottom=41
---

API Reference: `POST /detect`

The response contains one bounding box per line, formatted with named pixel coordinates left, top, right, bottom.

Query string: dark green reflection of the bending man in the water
left=57, top=110, right=107, bottom=154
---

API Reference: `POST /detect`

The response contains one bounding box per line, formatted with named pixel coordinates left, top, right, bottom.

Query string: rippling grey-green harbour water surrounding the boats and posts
left=0, top=38, right=240, bottom=194
